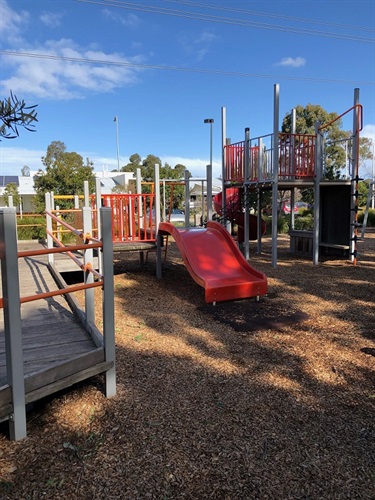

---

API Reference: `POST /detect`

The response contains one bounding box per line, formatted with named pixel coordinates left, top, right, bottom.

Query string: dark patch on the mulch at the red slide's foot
left=198, top=296, right=308, bottom=332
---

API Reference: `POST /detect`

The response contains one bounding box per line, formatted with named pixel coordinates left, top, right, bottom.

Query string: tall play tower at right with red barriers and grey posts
left=221, top=85, right=362, bottom=267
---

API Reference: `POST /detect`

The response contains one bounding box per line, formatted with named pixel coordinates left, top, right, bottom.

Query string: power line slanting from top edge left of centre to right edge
left=77, top=0, right=375, bottom=43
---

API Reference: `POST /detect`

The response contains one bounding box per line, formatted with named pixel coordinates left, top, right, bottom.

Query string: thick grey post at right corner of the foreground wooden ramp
left=100, top=207, right=116, bottom=398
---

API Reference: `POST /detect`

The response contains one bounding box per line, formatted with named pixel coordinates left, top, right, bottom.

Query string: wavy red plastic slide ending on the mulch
left=159, top=222, right=267, bottom=303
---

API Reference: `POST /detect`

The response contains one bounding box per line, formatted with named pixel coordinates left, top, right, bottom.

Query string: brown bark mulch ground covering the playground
left=0, top=230, right=375, bottom=500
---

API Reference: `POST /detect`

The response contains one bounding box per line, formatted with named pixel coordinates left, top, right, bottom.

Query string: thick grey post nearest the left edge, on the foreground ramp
left=0, top=208, right=26, bottom=441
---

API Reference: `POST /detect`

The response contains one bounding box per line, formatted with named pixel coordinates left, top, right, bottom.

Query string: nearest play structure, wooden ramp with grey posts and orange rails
left=0, top=208, right=116, bottom=440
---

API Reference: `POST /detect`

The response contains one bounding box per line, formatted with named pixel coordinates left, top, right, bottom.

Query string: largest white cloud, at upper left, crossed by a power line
left=1, top=38, right=147, bottom=99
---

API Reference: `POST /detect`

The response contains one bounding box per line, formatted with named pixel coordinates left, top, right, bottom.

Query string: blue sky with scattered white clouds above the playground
left=0, top=0, right=375, bottom=180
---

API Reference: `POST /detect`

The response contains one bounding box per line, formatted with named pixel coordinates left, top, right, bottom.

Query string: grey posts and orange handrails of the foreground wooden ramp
left=0, top=208, right=116, bottom=440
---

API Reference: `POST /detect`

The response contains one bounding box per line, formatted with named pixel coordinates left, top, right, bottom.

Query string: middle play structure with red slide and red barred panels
left=42, top=169, right=267, bottom=303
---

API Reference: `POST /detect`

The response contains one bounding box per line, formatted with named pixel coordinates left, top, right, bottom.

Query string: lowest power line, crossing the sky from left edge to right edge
left=0, top=50, right=375, bottom=85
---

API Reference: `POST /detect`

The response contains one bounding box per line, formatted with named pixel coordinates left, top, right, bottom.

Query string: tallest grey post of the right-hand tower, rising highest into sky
left=272, top=83, right=279, bottom=268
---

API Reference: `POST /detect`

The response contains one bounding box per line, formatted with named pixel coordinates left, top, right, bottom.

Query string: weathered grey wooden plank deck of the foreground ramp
left=0, top=242, right=111, bottom=421
